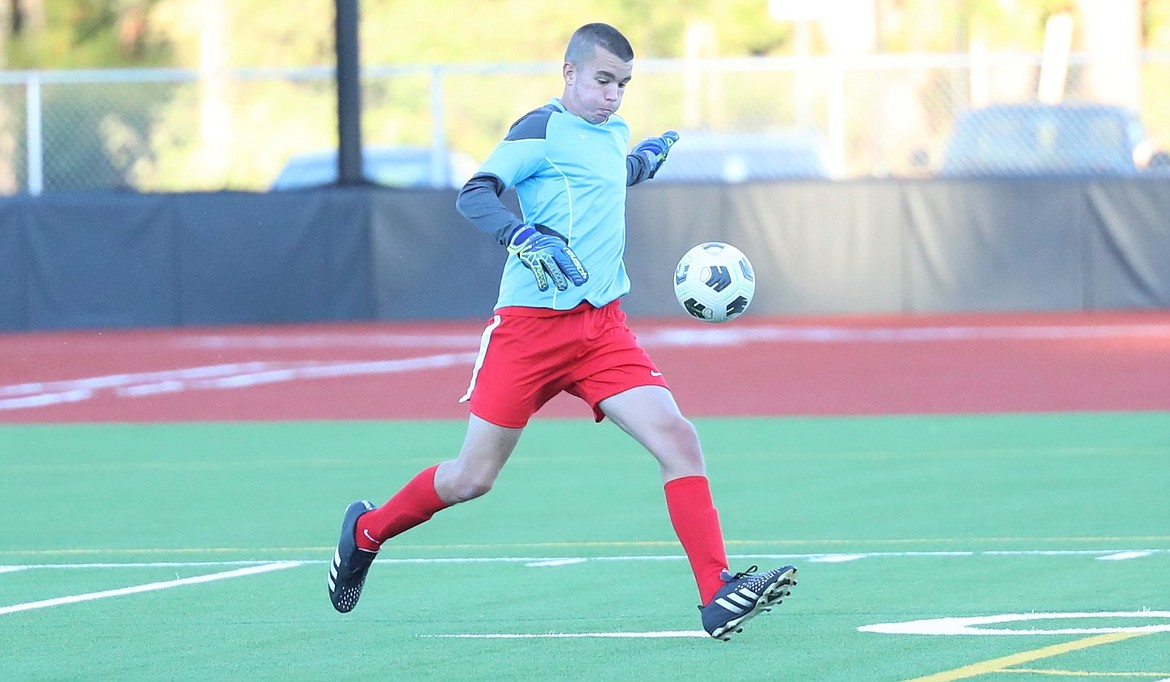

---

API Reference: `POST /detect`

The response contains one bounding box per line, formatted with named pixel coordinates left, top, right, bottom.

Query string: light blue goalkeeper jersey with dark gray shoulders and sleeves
left=456, top=98, right=646, bottom=310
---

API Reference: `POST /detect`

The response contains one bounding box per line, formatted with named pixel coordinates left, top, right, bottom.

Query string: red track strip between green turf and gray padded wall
left=0, top=311, right=1170, bottom=423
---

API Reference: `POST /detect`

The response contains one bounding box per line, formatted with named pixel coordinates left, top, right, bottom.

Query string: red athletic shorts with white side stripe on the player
left=460, top=301, right=667, bottom=428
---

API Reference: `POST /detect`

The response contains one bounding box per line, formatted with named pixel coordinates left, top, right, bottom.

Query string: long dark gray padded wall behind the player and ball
left=0, top=179, right=1170, bottom=330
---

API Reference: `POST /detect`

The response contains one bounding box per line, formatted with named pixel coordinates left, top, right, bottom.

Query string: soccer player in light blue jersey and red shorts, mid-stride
left=329, top=23, right=797, bottom=640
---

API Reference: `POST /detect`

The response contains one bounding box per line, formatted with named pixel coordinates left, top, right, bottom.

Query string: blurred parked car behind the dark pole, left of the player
left=271, top=146, right=477, bottom=190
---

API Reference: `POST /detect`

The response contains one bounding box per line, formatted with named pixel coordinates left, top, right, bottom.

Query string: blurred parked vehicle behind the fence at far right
left=938, top=103, right=1170, bottom=177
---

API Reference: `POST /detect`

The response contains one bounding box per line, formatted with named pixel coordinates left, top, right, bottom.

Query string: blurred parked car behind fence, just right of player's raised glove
left=654, top=131, right=830, bottom=182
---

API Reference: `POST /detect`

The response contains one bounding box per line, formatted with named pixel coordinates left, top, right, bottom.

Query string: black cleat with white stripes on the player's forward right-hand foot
left=698, top=566, right=797, bottom=641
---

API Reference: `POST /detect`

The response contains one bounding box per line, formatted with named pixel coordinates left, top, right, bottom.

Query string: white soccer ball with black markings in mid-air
left=674, top=241, right=756, bottom=322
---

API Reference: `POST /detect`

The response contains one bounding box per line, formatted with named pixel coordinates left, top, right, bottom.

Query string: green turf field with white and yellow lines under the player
left=0, top=413, right=1170, bottom=682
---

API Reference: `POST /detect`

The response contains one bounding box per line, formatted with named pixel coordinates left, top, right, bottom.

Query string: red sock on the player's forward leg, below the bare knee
left=663, top=476, right=728, bottom=604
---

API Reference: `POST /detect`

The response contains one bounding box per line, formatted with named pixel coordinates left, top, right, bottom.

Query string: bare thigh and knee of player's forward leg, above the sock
left=598, top=386, right=702, bottom=464
